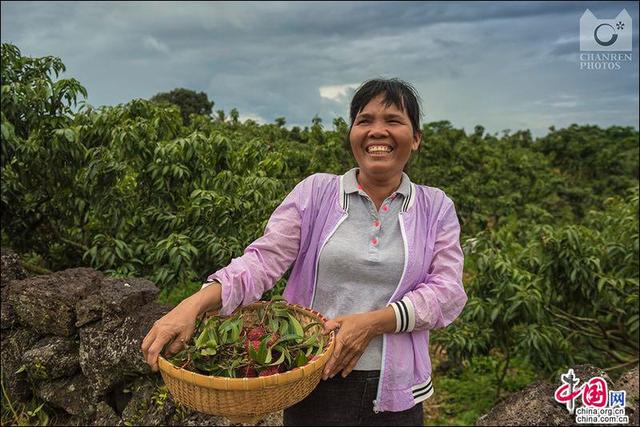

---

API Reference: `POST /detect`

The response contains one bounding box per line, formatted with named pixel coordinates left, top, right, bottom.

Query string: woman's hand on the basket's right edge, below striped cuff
left=322, top=313, right=375, bottom=380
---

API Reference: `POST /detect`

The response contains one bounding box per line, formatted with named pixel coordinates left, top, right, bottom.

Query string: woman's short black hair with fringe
left=349, top=78, right=420, bottom=135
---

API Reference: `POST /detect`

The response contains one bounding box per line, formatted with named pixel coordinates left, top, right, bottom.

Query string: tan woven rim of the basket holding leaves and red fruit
left=158, top=301, right=335, bottom=390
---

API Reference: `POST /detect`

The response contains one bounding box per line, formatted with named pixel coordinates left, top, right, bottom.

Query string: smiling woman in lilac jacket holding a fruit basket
left=142, top=79, right=467, bottom=425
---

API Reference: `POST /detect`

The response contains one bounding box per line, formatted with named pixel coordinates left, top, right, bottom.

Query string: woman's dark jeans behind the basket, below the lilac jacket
left=283, top=371, right=424, bottom=426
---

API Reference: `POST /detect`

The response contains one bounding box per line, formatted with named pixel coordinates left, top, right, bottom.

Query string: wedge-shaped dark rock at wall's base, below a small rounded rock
left=37, top=374, right=97, bottom=424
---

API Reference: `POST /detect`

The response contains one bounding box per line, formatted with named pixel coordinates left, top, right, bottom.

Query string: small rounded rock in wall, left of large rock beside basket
left=22, top=336, right=80, bottom=380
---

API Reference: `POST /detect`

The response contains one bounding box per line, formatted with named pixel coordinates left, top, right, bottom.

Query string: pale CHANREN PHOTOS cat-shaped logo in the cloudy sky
left=580, top=9, right=633, bottom=70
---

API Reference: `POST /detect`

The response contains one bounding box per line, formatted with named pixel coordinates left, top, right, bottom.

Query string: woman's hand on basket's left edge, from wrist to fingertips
left=142, top=301, right=199, bottom=372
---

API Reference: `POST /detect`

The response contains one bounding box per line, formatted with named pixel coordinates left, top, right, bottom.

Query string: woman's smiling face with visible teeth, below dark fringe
left=349, top=94, right=421, bottom=179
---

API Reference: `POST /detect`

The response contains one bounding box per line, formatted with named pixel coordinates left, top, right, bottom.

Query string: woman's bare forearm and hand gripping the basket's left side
left=142, top=283, right=222, bottom=372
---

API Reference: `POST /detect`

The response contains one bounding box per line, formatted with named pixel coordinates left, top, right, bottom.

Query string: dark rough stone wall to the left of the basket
left=0, top=248, right=282, bottom=425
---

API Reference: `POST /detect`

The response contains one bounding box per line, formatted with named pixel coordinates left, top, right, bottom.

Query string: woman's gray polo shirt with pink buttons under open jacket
left=312, top=168, right=411, bottom=370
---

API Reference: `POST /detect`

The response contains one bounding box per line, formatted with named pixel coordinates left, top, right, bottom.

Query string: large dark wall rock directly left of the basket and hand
left=80, top=303, right=171, bottom=395
